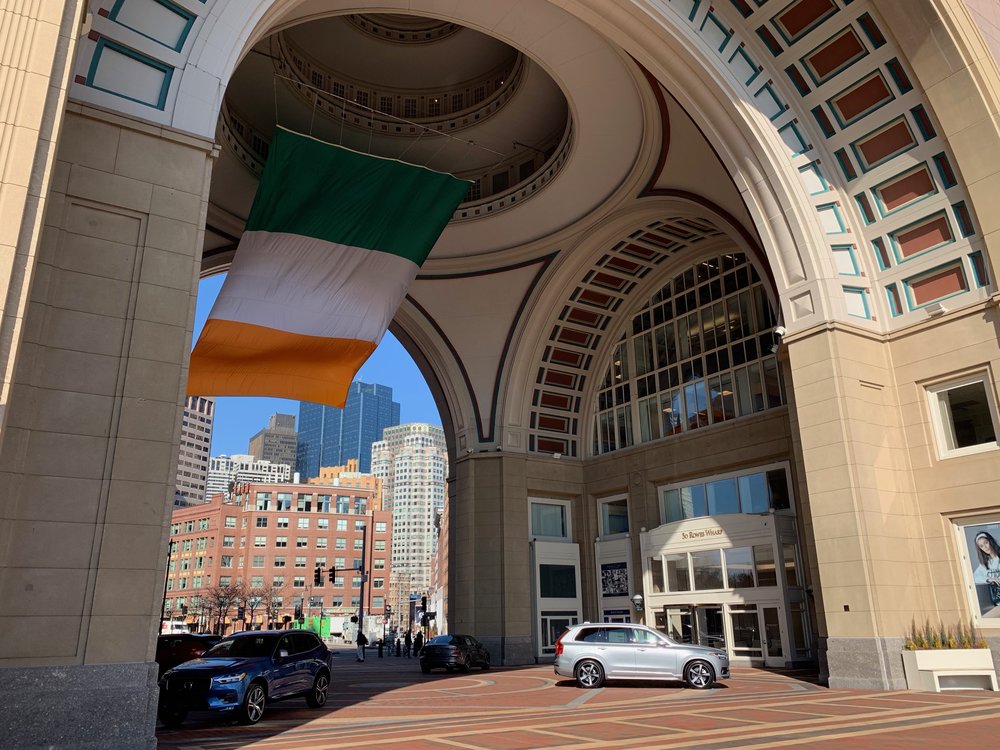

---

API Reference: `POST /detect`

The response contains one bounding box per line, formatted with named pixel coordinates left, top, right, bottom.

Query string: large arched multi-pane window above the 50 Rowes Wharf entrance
left=592, top=252, right=784, bottom=454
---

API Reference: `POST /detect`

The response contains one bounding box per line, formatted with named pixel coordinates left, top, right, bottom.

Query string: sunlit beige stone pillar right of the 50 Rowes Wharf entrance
left=786, top=324, right=933, bottom=689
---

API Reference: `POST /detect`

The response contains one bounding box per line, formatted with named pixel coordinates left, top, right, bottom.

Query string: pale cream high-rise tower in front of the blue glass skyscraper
left=372, top=422, right=448, bottom=598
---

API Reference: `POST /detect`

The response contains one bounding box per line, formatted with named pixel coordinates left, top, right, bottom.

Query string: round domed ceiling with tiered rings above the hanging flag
left=205, top=14, right=641, bottom=268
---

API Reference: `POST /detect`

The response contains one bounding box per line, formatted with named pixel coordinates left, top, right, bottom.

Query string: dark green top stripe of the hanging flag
left=246, top=128, right=468, bottom=266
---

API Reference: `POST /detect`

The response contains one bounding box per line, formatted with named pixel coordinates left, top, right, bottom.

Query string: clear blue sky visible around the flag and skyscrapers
left=192, top=274, right=441, bottom=456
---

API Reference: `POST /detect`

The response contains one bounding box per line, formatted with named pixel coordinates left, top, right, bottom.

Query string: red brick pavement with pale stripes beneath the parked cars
left=158, top=647, right=1000, bottom=750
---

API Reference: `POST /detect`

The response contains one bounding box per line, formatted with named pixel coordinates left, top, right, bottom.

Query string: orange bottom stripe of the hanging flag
left=187, top=318, right=376, bottom=408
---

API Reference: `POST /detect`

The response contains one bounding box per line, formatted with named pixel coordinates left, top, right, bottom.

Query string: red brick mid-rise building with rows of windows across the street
left=164, top=484, right=392, bottom=634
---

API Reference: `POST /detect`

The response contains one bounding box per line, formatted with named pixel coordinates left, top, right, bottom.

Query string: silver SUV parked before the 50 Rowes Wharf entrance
left=554, top=622, right=729, bottom=690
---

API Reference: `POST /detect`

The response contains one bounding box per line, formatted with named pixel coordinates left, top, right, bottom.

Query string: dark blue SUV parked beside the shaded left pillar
left=159, top=630, right=332, bottom=726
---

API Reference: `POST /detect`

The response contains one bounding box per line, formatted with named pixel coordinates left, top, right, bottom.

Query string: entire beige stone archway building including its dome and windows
left=0, top=0, right=1000, bottom=748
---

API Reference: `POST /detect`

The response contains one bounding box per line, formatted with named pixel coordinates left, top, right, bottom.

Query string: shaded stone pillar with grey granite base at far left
left=0, top=105, right=213, bottom=748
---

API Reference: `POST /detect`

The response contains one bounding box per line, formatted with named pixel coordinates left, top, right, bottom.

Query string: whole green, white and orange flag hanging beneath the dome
left=188, top=128, right=468, bottom=407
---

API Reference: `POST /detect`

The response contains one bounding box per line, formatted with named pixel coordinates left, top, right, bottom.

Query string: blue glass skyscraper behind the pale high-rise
left=295, top=381, right=399, bottom=481
